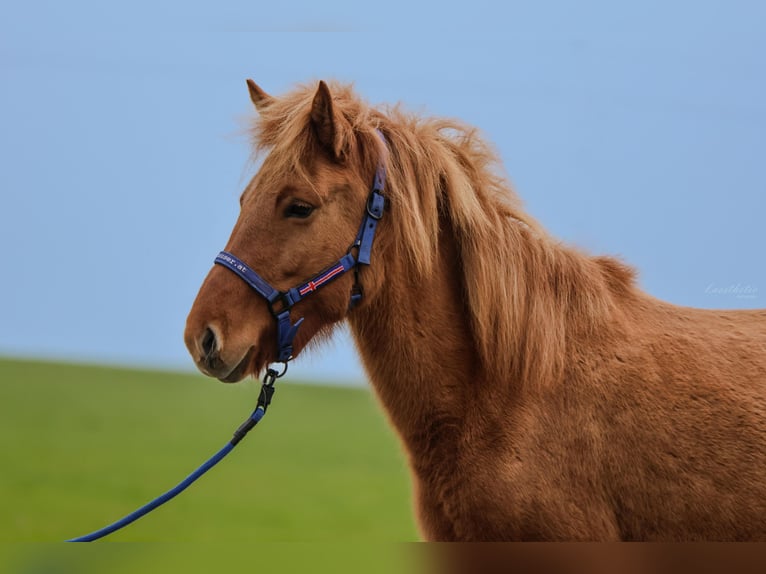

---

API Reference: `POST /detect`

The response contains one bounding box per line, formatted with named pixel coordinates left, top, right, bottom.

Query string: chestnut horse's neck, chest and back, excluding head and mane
left=350, top=217, right=766, bottom=541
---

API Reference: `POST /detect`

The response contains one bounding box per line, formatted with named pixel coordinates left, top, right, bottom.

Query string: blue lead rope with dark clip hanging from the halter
left=67, top=369, right=284, bottom=542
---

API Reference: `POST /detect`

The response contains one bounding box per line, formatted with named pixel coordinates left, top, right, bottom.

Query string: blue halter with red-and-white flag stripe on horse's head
left=215, top=130, right=386, bottom=363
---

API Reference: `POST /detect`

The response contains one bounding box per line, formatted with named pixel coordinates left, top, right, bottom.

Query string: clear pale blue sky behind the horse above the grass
left=0, top=0, right=766, bottom=383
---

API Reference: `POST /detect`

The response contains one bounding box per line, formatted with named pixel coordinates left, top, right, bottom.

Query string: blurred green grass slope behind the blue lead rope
left=0, top=360, right=417, bottom=542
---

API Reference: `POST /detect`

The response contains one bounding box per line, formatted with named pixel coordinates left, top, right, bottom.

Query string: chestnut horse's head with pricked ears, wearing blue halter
left=184, top=80, right=385, bottom=382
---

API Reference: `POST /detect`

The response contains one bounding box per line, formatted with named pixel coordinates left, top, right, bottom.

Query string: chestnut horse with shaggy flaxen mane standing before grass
left=185, top=80, right=766, bottom=541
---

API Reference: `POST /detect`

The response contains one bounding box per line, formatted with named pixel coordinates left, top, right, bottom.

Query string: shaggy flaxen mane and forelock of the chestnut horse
left=253, top=82, right=635, bottom=388
